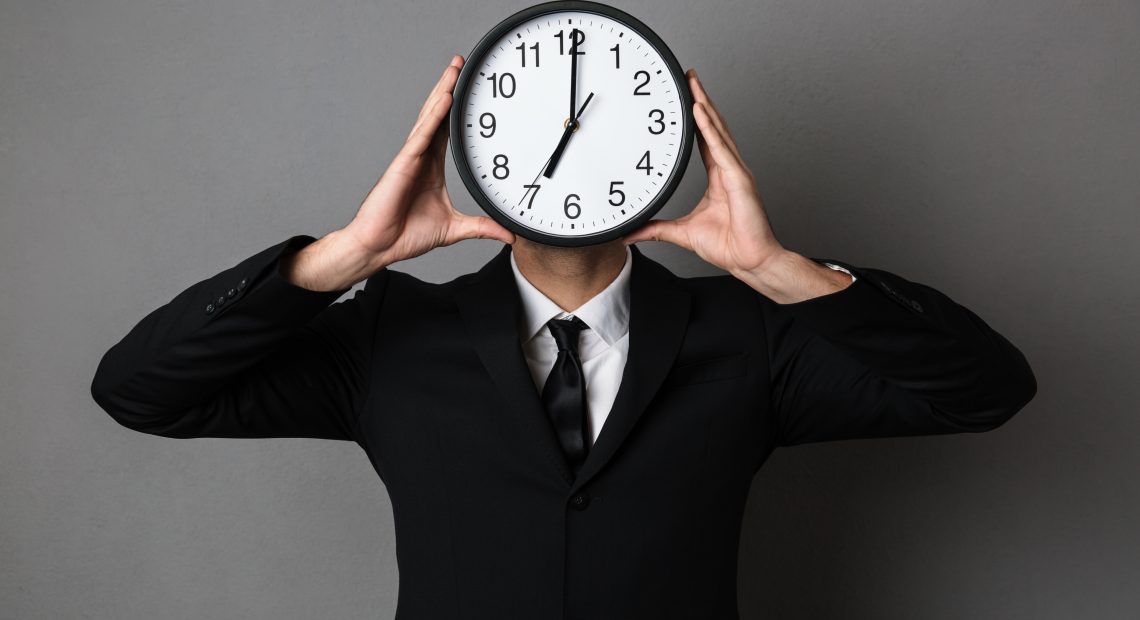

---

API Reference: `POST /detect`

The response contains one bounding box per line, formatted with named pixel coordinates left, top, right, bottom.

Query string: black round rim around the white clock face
left=450, top=0, right=697, bottom=247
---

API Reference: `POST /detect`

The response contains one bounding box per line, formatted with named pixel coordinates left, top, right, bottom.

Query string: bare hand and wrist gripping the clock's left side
left=280, top=56, right=514, bottom=291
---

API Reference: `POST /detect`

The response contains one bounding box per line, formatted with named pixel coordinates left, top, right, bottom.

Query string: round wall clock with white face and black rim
left=450, top=1, right=694, bottom=246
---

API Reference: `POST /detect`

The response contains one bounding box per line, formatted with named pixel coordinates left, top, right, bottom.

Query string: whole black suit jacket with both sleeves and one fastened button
left=91, top=235, right=1036, bottom=620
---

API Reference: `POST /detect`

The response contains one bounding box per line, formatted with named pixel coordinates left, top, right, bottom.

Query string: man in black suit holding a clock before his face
left=91, top=57, right=1036, bottom=620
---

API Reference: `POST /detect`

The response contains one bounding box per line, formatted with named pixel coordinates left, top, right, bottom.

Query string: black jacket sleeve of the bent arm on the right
left=758, top=259, right=1037, bottom=446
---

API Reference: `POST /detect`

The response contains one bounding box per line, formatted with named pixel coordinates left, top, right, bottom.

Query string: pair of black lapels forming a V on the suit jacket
left=456, top=245, right=690, bottom=492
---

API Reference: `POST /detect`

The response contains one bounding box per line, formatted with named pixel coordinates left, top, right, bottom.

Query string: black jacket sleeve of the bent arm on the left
left=91, top=235, right=388, bottom=440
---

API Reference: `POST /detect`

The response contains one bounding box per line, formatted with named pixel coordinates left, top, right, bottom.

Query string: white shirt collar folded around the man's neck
left=511, top=246, right=633, bottom=345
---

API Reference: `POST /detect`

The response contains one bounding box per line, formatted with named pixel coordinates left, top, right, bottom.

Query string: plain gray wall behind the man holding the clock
left=0, top=0, right=1140, bottom=620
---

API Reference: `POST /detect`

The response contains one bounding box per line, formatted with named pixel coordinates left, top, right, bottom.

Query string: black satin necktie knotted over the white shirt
left=543, top=317, right=589, bottom=473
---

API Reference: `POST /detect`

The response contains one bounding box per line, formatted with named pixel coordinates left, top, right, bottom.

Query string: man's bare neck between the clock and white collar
left=511, top=236, right=626, bottom=312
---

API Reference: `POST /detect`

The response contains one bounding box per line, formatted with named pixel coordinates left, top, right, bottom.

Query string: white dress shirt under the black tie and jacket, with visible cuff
left=511, top=246, right=855, bottom=446
